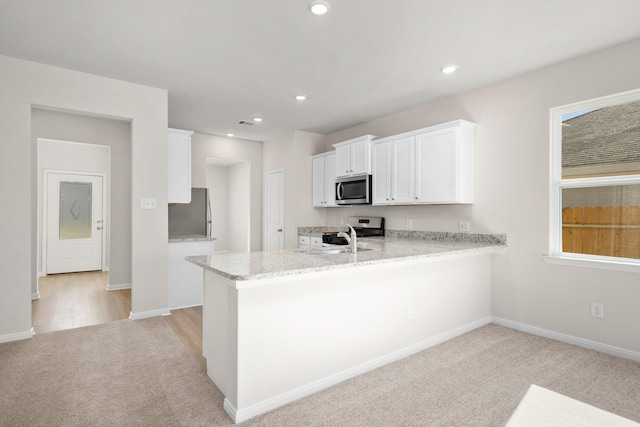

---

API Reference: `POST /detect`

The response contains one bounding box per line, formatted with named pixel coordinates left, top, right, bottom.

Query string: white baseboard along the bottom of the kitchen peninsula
left=228, top=317, right=491, bottom=423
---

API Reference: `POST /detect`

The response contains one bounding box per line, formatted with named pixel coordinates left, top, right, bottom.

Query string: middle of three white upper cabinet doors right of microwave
left=391, top=136, right=414, bottom=204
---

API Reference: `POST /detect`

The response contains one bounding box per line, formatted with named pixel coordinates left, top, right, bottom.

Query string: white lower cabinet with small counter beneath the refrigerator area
left=168, top=240, right=212, bottom=310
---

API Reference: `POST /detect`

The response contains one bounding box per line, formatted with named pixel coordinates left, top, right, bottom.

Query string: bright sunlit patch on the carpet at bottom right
left=506, top=384, right=640, bottom=427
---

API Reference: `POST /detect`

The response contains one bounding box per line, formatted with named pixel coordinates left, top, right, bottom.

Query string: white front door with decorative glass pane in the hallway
left=45, top=173, right=105, bottom=274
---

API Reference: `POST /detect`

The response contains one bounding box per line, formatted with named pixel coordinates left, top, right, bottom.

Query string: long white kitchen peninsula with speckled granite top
left=187, top=230, right=506, bottom=422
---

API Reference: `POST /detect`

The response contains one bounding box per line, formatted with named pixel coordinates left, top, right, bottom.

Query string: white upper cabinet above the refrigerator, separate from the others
left=167, top=129, right=193, bottom=203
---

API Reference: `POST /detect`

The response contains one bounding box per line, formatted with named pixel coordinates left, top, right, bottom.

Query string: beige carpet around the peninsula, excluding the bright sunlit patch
left=0, top=318, right=640, bottom=427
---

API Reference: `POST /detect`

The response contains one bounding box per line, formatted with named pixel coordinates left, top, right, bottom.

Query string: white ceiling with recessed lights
left=0, top=0, right=640, bottom=141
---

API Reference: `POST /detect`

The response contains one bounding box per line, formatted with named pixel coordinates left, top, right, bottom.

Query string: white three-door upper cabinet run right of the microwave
left=372, top=120, right=475, bottom=205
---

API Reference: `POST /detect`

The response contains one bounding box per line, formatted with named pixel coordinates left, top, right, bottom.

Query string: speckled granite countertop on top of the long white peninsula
left=186, top=230, right=507, bottom=281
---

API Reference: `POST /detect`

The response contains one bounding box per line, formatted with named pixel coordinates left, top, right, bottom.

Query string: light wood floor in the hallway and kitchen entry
left=31, top=271, right=206, bottom=368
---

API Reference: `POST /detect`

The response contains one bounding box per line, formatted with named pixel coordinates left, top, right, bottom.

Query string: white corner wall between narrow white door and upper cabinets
left=263, top=130, right=326, bottom=248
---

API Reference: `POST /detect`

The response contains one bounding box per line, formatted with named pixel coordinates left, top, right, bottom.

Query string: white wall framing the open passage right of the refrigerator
left=191, top=133, right=262, bottom=251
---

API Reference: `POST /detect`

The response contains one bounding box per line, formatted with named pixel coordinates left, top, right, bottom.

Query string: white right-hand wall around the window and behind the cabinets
left=326, top=40, right=640, bottom=352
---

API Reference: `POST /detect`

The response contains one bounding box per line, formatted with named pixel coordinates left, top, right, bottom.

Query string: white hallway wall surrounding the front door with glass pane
left=31, top=108, right=131, bottom=289
